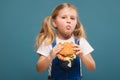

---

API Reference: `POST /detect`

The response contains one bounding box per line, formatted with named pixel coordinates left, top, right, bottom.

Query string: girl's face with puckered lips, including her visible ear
left=53, top=7, right=77, bottom=39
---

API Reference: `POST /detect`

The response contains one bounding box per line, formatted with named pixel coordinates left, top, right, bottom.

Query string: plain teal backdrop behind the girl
left=0, top=0, right=120, bottom=80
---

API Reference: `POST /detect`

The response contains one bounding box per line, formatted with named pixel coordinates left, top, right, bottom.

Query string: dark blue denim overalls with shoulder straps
left=48, top=38, right=82, bottom=80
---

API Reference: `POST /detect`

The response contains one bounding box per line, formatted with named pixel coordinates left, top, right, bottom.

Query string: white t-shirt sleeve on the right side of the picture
left=80, top=38, right=94, bottom=55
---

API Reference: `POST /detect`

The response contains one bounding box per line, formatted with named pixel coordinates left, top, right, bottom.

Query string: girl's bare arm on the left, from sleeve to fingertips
left=36, top=45, right=63, bottom=72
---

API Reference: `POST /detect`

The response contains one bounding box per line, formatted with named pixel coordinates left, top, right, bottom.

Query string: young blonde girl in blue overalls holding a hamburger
left=36, top=3, right=95, bottom=80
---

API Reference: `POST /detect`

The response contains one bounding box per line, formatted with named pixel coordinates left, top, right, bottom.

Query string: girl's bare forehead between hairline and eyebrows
left=58, top=7, right=77, bottom=16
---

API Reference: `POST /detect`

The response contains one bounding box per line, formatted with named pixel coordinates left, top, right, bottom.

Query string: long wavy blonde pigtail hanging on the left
left=35, top=16, right=54, bottom=48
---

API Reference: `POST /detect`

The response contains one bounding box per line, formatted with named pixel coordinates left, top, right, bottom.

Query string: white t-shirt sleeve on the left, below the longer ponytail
left=37, top=45, right=52, bottom=56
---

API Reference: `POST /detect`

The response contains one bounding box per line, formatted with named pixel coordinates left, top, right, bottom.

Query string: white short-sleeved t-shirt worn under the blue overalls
left=37, top=36, right=94, bottom=56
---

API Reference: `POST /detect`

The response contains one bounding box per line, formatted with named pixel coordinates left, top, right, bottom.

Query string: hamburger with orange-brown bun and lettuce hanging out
left=58, top=42, right=76, bottom=67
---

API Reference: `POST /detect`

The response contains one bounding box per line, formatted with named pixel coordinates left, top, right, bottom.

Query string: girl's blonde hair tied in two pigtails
left=35, top=3, right=86, bottom=48
